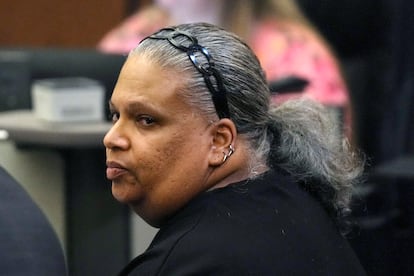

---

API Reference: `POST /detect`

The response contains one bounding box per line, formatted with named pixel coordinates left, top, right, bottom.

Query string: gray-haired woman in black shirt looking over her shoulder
left=104, top=23, right=364, bottom=275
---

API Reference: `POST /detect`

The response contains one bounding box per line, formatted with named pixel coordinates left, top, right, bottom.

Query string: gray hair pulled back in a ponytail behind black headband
left=131, top=23, right=363, bottom=231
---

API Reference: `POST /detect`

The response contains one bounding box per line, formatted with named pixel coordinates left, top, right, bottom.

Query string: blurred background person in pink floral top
left=98, top=0, right=352, bottom=138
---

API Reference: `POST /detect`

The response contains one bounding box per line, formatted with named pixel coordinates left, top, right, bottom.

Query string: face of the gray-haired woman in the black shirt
left=104, top=55, right=212, bottom=226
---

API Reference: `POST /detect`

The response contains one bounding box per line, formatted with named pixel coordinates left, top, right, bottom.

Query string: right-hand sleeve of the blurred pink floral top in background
left=250, top=20, right=351, bottom=135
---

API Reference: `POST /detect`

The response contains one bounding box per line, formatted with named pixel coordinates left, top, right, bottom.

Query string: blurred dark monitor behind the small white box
left=0, top=48, right=126, bottom=117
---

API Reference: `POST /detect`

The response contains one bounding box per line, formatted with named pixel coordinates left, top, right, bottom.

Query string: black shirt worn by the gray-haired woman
left=120, top=168, right=365, bottom=275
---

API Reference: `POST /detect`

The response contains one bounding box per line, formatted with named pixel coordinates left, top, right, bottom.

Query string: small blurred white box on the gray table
left=31, top=77, right=105, bottom=122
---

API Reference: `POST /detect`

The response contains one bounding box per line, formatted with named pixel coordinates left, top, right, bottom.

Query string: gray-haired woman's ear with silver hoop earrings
left=209, top=119, right=237, bottom=167
